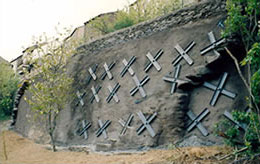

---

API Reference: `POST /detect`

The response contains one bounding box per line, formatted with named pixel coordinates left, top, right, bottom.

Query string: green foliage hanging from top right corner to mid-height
left=223, top=0, right=260, bottom=105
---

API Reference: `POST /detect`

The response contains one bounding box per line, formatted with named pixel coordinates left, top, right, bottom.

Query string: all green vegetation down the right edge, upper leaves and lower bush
left=214, top=0, right=260, bottom=158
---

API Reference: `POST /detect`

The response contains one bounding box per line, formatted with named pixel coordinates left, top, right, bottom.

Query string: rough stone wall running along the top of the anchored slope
left=78, top=0, right=226, bottom=53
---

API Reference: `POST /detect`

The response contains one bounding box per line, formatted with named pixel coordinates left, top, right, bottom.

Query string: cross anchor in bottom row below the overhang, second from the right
left=187, top=108, right=209, bottom=136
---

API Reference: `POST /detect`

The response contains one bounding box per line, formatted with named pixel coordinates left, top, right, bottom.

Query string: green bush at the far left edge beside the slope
left=0, top=63, right=18, bottom=119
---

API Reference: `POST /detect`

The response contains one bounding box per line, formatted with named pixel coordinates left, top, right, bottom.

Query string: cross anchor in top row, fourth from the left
left=144, top=49, right=163, bottom=72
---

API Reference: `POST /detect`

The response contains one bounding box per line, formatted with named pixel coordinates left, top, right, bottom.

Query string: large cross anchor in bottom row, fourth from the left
left=136, top=111, right=157, bottom=137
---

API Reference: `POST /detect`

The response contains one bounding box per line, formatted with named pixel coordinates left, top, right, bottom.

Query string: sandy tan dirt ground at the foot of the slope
left=0, top=131, right=233, bottom=164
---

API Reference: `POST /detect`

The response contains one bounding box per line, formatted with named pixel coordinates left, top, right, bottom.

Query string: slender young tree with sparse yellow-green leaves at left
left=25, top=28, right=79, bottom=151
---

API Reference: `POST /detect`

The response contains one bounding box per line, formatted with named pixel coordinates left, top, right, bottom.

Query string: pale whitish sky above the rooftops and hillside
left=0, top=0, right=135, bottom=61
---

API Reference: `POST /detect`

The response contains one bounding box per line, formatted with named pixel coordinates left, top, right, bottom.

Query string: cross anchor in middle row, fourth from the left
left=130, top=75, right=150, bottom=97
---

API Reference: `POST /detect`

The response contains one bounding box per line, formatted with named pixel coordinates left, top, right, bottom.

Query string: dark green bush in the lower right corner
left=214, top=112, right=260, bottom=155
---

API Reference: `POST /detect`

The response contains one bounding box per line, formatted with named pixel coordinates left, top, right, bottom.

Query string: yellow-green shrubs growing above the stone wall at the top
left=90, top=0, right=181, bottom=34
